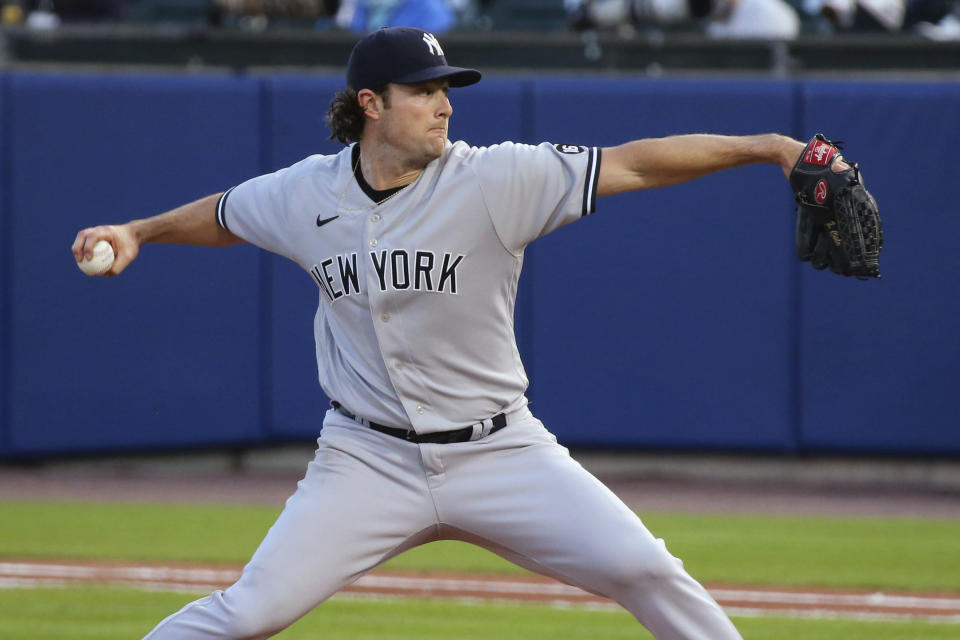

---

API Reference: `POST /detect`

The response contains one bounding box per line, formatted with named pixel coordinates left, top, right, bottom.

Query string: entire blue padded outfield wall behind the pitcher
left=0, top=72, right=960, bottom=458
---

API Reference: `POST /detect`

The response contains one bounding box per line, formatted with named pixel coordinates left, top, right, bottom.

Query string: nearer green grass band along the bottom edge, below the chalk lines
left=0, top=588, right=960, bottom=640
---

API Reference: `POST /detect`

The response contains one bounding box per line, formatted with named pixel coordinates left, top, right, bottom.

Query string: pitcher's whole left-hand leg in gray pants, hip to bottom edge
left=148, top=430, right=435, bottom=640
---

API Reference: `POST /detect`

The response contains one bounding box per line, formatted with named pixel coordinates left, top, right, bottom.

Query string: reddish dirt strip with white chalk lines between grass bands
left=0, top=562, right=960, bottom=624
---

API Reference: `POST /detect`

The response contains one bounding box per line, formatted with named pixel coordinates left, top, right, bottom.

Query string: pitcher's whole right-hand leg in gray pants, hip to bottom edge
left=441, top=425, right=740, bottom=640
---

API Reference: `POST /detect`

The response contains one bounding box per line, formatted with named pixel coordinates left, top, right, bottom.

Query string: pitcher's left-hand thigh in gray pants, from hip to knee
left=226, top=428, right=436, bottom=616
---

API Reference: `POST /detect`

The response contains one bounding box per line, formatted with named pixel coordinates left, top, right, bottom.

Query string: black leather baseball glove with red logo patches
left=790, top=133, right=883, bottom=280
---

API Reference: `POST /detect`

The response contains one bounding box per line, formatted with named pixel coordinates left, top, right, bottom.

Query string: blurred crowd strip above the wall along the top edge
left=0, top=0, right=960, bottom=40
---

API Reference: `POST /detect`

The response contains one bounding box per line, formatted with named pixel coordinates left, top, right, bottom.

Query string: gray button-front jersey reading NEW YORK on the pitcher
left=217, top=142, right=600, bottom=433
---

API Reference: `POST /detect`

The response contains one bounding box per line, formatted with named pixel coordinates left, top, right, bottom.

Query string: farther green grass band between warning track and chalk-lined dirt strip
left=0, top=502, right=960, bottom=592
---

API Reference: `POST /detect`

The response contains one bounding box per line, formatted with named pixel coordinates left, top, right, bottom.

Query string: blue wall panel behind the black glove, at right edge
left=799, top=82, right=960, bottom=454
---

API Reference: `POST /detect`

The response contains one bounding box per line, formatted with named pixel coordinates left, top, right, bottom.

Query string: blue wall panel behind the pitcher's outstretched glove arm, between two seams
left=528, top=78, right=797, bottom=451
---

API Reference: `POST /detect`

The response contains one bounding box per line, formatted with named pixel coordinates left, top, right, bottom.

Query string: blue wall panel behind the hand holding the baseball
left=4, top=73, right=262, bottom=454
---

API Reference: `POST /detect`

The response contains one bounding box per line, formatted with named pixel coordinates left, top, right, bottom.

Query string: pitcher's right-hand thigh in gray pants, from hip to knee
left=438, top=432, right=679, bottom=593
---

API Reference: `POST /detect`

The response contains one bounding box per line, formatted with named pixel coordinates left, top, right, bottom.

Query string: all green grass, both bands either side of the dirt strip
left=0, top=502, right=960, bottom=640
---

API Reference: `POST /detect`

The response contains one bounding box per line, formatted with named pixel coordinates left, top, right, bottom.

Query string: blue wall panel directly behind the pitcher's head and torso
left=266, top=76, right=530, bottom=438
